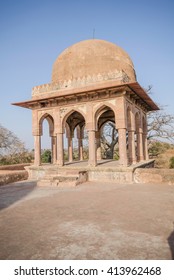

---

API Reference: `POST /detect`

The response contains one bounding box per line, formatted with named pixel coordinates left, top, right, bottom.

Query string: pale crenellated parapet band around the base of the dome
left=32, top=70, right=130, bottom=96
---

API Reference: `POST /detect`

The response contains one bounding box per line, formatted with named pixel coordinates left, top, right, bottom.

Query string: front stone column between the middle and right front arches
left=88, top=130, right=97, bottom=166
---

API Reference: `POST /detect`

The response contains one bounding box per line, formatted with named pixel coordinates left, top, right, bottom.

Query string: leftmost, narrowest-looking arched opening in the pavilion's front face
left=39, top=114, right=56, bottom=164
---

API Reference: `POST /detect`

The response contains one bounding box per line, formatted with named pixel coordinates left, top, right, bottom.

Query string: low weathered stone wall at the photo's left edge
left=0, top=170, right=28, bottom=186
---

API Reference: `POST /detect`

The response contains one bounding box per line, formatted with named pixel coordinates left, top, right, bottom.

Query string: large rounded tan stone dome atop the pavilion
left=52, top=39, right=136, bottom=83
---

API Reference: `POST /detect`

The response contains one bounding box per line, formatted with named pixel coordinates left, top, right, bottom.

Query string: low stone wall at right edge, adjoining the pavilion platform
left=133, top=168, right=174, bottom=185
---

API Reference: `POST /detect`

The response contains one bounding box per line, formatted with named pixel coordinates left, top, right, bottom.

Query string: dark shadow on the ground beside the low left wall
left=0, top=181, right=36, bottom=210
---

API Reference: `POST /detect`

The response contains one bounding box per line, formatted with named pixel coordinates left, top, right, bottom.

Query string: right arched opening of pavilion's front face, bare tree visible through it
left=96, top=106, right=119, bottom=161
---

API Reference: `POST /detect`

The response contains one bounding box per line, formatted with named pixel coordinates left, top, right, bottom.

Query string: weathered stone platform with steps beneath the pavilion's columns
left=26, top=160, right=154, bottom=186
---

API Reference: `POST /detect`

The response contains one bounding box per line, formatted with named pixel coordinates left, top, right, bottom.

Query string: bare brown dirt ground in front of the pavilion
left=0, top=181, right=174, bottom=260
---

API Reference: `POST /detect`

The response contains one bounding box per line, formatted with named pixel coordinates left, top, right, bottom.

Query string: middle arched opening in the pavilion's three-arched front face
left=64, top=111, right=85, bottom=163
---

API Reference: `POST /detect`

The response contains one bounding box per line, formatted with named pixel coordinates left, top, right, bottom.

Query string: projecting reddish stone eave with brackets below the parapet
left=13, top=81, right=159, bottom=111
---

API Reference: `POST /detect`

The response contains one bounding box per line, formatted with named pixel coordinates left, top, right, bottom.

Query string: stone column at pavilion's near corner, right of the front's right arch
left=118, top=128, right=128, bottom=166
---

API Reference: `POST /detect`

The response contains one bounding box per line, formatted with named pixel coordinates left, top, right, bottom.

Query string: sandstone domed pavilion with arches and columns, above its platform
left=12, top=39, right=158, bottom=178
